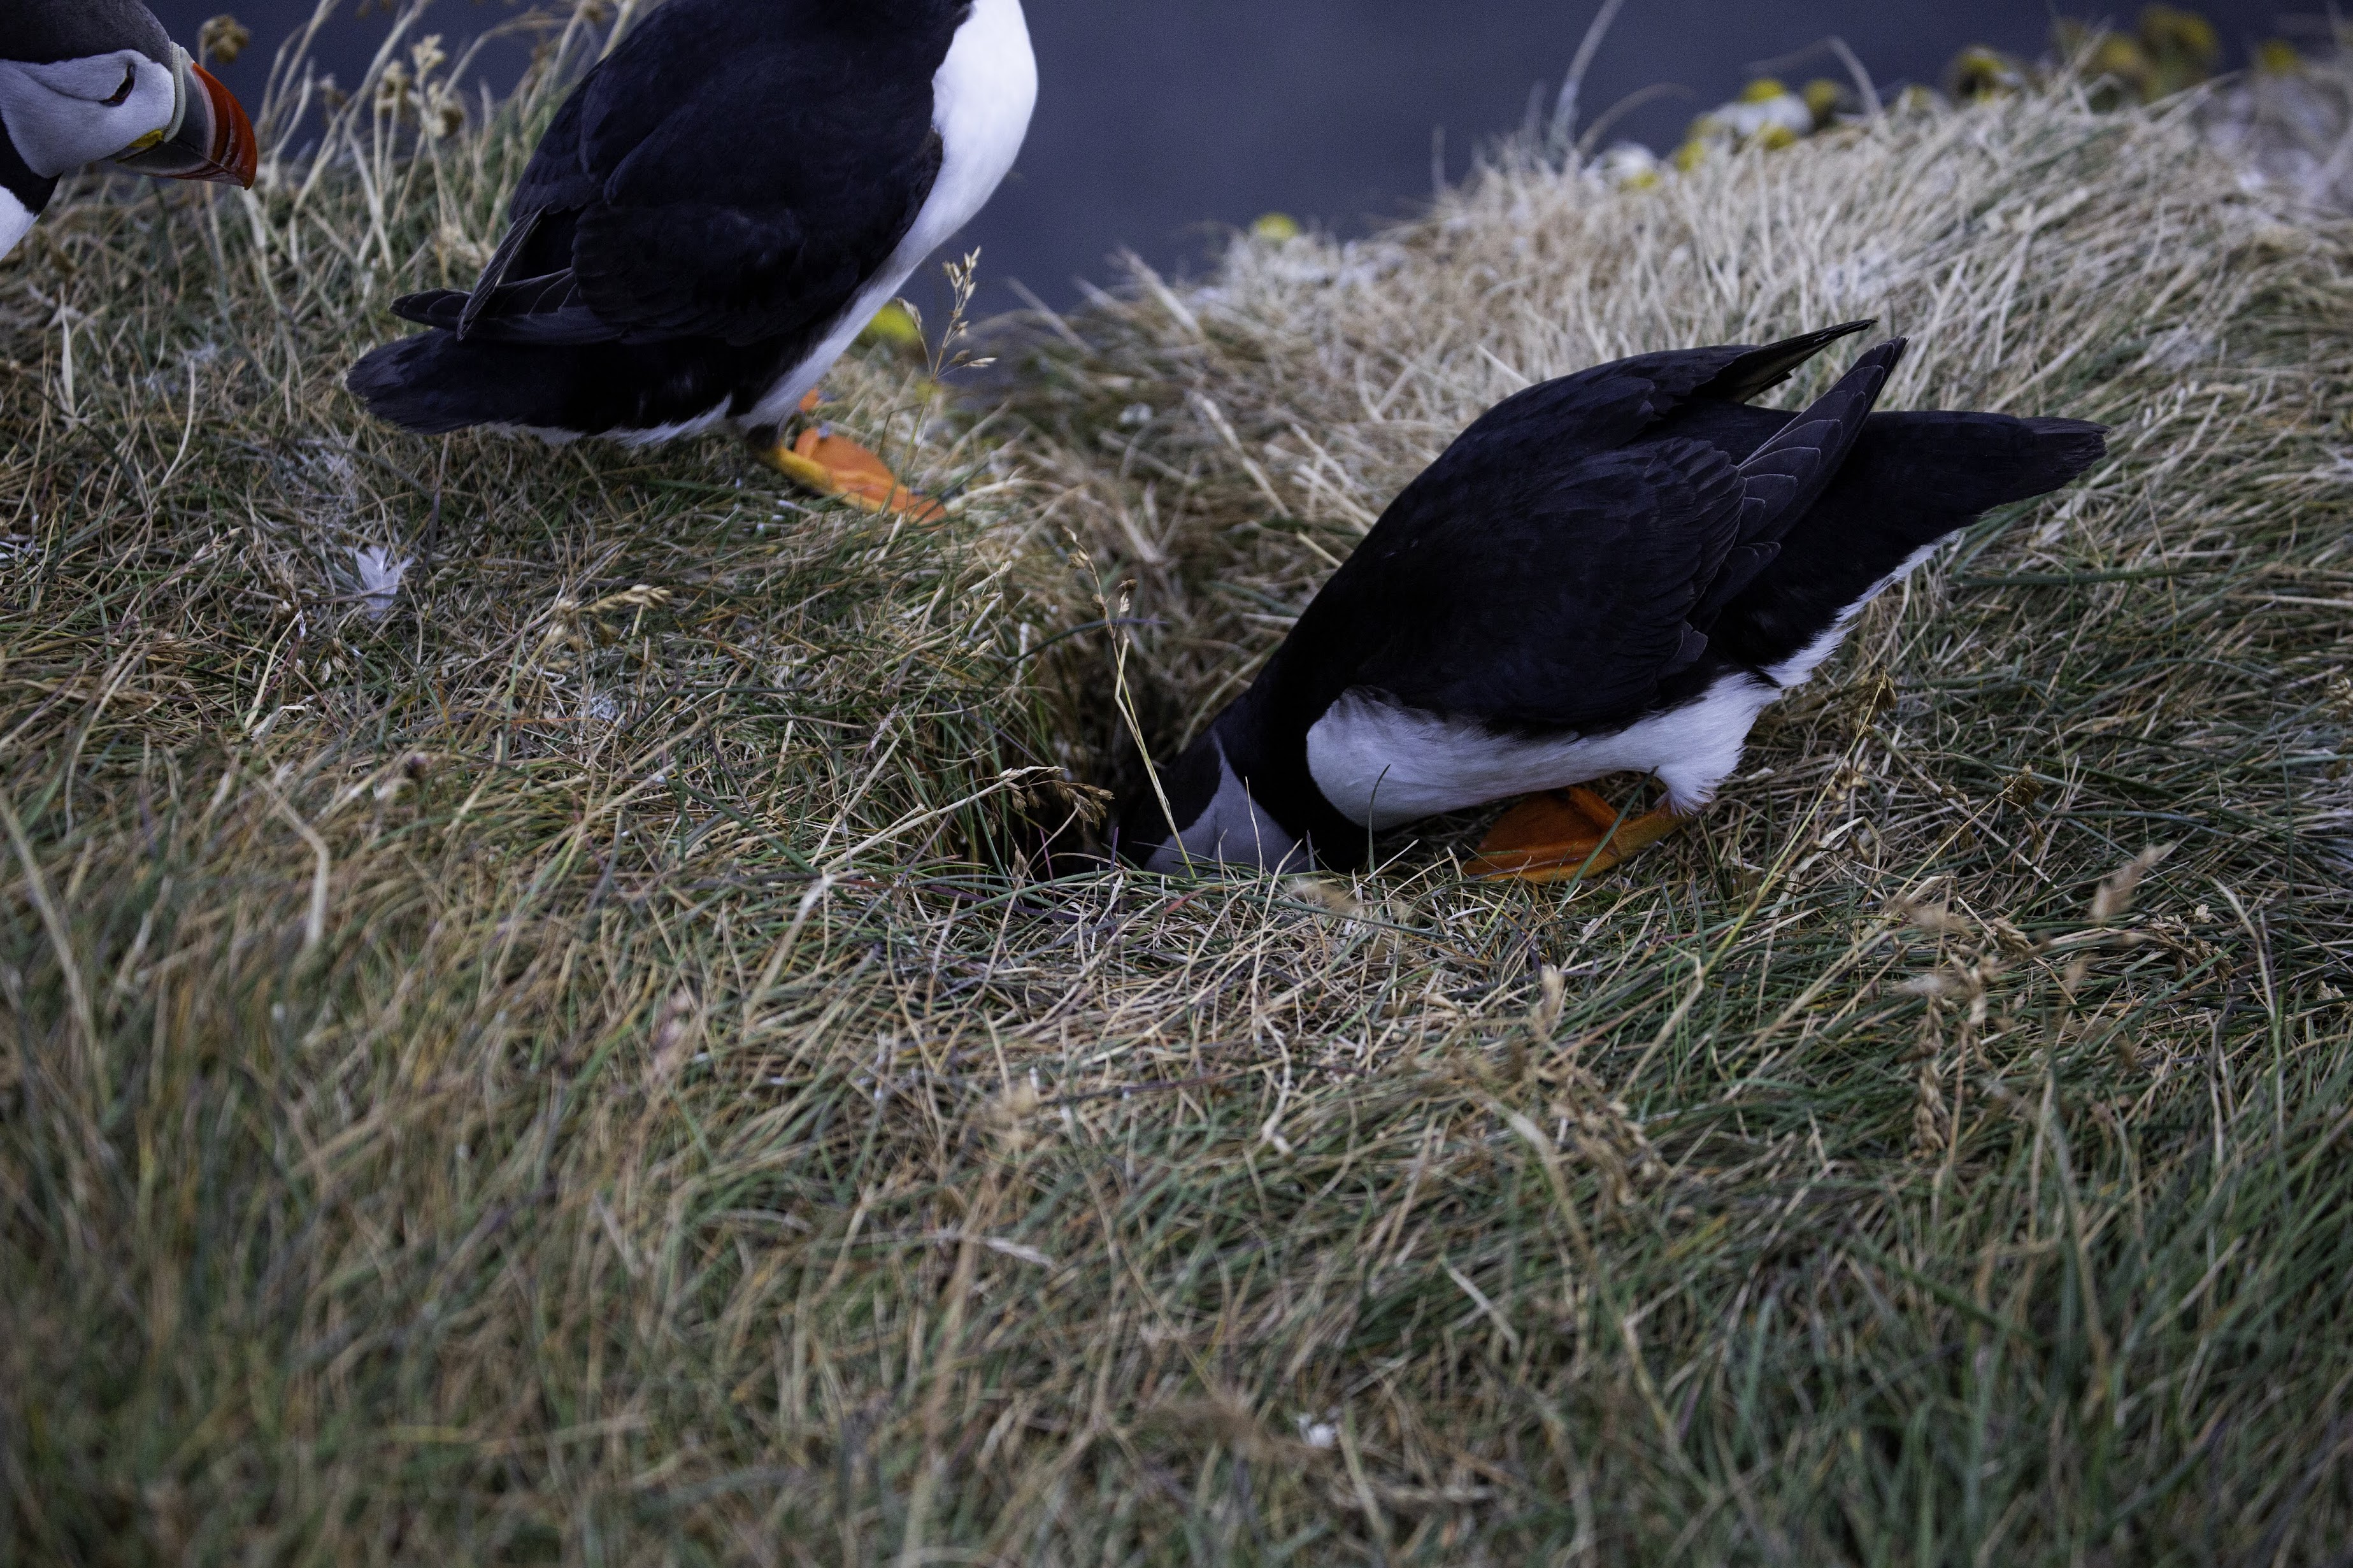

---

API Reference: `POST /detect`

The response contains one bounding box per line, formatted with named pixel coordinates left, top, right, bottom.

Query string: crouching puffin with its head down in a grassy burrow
left=1118, top=322, right=2106, bottom=881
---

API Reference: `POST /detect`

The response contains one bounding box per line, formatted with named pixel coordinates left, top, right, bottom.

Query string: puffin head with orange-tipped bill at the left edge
left=0, top=0, right=261, bottom=257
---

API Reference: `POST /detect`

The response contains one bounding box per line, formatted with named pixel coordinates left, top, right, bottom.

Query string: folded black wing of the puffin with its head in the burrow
left=1285, top=339, right=1903, bottom=730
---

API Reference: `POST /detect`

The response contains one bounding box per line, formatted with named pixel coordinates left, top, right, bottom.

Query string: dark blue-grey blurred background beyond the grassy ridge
left=152, top=0, right=2318, bottom=311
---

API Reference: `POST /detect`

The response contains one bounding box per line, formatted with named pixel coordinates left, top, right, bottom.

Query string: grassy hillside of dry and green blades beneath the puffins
left=0, top=18, right=2353, bottom=1564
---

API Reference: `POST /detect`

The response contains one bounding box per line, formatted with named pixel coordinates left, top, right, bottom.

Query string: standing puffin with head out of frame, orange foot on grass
left=348, top=0, right=1038, bottom=513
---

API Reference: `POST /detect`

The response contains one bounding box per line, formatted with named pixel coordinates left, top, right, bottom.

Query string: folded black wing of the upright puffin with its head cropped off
left=393, top=0, right=953, bottom=344
